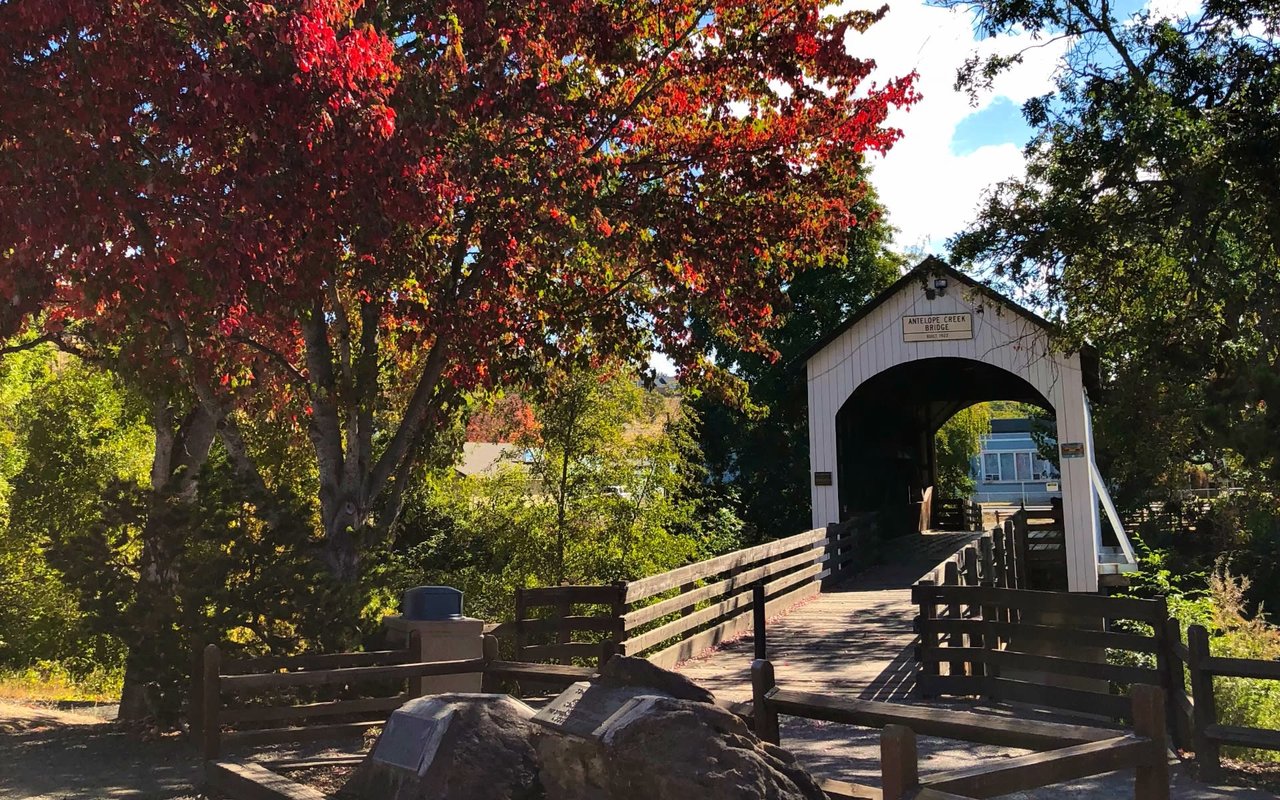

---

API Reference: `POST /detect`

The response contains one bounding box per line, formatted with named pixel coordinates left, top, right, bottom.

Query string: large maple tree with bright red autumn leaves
left=0, top=0, right=914, bottom=627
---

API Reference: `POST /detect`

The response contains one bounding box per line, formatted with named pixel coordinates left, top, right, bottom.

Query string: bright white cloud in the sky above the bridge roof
left=838, top=0, right=1070, bottom=251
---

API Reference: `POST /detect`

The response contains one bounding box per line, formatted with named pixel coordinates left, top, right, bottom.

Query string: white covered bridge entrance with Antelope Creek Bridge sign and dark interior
left=803, top=257, right=1100, bottom=591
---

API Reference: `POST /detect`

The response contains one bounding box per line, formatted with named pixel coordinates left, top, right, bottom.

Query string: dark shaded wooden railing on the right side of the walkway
left=911, top=581, right=1171, bottom=718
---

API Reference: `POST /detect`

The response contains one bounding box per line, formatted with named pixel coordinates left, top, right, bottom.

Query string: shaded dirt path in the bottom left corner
left=0, top=701, right=200, bottom=800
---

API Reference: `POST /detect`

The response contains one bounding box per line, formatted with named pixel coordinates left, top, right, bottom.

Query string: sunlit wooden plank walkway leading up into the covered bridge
left=676, top=532, right=982, bottom=701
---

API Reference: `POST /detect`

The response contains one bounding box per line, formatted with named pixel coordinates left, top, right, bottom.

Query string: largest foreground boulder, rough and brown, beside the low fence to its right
left=538, top=695, right=827, bottom=800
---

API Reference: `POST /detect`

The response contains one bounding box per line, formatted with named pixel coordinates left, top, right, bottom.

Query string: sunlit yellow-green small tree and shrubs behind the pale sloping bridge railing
left=379, top=369, right=740, bottom=620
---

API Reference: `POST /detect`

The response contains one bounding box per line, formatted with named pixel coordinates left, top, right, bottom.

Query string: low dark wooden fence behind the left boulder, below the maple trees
left=191, top=631, right=594, bottom=759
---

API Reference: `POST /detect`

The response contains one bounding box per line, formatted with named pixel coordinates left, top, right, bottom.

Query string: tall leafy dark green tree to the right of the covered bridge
left=942, top=0, right=1280, bottom=502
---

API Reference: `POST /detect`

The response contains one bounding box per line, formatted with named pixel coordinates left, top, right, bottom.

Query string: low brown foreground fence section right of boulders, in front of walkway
left=751, top=660, right=1169, bottom=800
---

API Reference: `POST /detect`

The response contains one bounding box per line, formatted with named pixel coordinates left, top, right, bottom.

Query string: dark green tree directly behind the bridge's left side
left=695, top=188, right=906, bottom=540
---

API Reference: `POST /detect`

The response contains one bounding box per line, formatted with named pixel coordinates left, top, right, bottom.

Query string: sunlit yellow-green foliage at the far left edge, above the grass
left=0, top=348, right=152, bottom=671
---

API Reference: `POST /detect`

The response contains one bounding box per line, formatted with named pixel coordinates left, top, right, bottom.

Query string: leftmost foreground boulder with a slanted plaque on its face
left=343, top=694, right=543, bottom=800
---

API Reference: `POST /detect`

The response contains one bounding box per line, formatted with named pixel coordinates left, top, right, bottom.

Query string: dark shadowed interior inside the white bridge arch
left=836, top=358, right=1053, bottom=532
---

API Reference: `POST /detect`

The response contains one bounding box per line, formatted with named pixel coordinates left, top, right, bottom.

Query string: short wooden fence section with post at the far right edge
left=1166, top=620, right=1280, bottom=781
